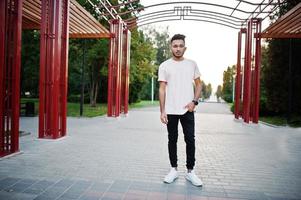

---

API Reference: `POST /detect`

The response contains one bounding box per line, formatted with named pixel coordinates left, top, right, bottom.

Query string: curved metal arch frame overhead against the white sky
left=120, top=0, right=283, bottom=29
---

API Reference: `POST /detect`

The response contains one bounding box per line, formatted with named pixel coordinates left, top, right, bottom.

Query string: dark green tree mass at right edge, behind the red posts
left=261, top=0, right=301, bottom=117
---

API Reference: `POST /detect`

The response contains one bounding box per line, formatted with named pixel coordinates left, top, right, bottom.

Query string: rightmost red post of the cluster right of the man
left=253, top=19, right=261, bottom=123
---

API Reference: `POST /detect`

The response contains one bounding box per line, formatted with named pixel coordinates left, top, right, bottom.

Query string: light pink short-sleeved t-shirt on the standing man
left=158, top=58, right=201, bottom=115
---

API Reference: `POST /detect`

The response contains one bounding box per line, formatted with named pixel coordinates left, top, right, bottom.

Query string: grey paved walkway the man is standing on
left=0, top=103, right=301, bottom=200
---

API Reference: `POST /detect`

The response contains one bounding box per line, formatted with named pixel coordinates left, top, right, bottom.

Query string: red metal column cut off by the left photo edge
left=0, top=0, right=22, bottom=157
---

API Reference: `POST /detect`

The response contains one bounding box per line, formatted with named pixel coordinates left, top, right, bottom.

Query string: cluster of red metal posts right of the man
left=234, top=18, right=261, bottom=123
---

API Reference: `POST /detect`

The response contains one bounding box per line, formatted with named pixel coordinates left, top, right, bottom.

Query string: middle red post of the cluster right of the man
left=243, top=19, right=253, bottom=123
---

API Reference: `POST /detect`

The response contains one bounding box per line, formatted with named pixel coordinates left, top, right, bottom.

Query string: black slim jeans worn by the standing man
left=167, top=111, right=195, bottom=169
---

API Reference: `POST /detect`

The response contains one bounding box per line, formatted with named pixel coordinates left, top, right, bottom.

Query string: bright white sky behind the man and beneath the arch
left=140, top=0, right=272, bottom=92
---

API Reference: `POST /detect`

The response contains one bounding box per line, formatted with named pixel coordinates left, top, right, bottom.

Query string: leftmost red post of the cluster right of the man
left=234, top=30, right=242, bottom=119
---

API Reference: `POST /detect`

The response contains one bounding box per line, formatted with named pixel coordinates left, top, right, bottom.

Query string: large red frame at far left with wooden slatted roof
left=0, top=0, right=109, bottom=157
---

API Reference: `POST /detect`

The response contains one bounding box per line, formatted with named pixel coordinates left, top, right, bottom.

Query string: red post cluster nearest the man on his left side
left=107, top=19, right=130, bottom=117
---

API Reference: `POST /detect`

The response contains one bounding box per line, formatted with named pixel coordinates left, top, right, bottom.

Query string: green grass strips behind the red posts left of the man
left=21, top=98, right=159, bottom=117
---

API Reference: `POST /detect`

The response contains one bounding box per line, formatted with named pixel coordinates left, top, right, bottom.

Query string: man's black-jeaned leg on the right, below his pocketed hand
left=180, top=112, right=195, bottom=171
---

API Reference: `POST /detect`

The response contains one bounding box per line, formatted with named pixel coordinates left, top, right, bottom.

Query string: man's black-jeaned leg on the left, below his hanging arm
left=167, top=115, right=179, bottom=168
